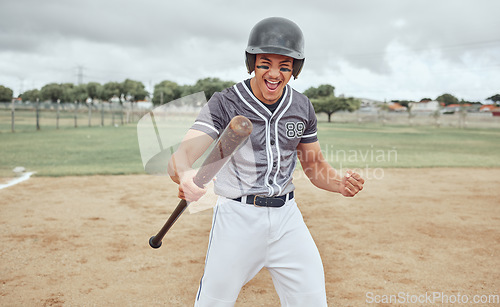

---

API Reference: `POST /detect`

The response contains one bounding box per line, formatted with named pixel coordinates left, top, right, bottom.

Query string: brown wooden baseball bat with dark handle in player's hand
left=149, top=115, right=253, bottom=248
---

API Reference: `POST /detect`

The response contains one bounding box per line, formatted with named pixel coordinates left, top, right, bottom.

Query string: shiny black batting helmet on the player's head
left=245, top=17, right=305, bottom=79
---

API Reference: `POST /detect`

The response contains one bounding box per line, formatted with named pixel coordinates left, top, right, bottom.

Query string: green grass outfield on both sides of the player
left=0, top=123, right=500, bottom=176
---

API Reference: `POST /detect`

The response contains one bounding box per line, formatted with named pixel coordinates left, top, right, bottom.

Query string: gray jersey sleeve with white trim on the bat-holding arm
left=191, top=93, right=229, bottom=140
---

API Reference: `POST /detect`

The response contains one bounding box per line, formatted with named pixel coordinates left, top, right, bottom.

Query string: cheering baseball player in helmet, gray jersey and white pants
left=169, top=17, right=364, bottom=307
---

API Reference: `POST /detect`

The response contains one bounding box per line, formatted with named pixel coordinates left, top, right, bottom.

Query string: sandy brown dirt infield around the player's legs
left=0, top=169, right=500, bottom=306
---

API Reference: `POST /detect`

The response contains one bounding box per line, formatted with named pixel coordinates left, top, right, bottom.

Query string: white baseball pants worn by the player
left=195, top=197, right=327, bottom=307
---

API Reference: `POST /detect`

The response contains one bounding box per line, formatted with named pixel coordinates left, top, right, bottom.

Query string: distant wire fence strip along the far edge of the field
left=0, top=102, right=500, bottom=132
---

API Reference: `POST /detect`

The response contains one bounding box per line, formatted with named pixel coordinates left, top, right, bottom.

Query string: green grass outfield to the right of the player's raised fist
left=318, top=123, right=500, bottom=168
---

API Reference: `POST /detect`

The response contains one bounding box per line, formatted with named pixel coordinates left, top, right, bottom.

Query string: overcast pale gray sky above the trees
left=0, top=0, right=500, bottom=102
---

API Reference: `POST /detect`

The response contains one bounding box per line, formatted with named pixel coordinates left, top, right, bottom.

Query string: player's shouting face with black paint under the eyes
left=250, top=54, right=293, bottom=104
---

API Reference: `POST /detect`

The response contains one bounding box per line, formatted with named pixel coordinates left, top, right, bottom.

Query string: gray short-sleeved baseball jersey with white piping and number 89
left=191, top=82, right=318, bottom=198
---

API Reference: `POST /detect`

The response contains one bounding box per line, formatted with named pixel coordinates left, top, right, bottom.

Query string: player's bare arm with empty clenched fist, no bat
left=297, top=142, right=365, bottom=197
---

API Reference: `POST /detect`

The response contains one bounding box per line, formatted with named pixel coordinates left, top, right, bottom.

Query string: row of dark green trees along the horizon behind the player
left=0, top=78, right=500, bottom=121
